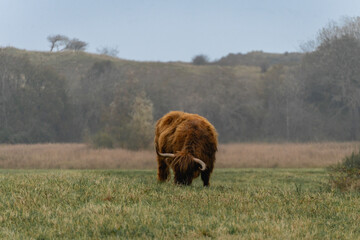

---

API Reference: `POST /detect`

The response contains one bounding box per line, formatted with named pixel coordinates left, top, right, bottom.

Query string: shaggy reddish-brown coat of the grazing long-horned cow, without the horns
left=155, top=111, right=217, bottom=186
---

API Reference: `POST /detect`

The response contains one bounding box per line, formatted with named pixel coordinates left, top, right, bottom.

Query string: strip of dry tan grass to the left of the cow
left=0, top=143, right=155, bottom=169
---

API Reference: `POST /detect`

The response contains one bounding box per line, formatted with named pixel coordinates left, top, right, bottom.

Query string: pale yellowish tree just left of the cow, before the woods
left=93, top=69, right=154, bottom=150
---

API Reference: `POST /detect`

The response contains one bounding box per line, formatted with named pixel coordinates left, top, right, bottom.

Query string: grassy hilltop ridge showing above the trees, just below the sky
left=3, top=48, right=268, bottom=97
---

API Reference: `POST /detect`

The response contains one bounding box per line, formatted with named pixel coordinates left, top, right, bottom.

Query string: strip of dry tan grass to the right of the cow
left=217, top=142, right=360, bottom=168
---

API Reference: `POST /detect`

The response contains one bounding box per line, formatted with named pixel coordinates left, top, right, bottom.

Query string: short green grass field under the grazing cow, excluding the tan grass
left=0, top=169, right=360, bottom=239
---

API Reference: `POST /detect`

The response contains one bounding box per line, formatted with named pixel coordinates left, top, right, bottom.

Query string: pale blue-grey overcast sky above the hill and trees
left=0, top=0, right=360, bottom=62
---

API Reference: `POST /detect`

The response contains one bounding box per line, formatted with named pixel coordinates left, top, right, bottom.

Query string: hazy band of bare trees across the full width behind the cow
left=0, top=18, right=360, bottom=149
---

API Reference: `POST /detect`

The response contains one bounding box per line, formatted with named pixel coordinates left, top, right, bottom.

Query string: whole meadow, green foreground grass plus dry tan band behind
left=0, top=143, right=360, bottom=239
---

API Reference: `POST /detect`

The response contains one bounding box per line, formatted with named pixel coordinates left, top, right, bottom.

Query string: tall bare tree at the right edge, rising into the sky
left=302, top=32, right=360, bottom=140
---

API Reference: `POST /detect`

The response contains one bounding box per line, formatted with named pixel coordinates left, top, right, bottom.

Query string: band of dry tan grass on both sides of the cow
left=0, top=142, right=360, bottom=169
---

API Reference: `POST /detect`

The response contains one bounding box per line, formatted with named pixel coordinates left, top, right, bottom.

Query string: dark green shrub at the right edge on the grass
left=329, top=151, right=360, bottom=191
